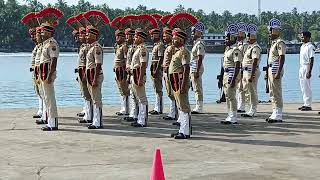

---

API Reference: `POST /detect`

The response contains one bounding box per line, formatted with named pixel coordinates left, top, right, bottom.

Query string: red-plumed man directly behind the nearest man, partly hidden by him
left=160, top=14, right=178, bottom=120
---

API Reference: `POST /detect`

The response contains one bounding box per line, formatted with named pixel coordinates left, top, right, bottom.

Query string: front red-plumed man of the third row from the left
left=130, top=15, right=158, bottom=127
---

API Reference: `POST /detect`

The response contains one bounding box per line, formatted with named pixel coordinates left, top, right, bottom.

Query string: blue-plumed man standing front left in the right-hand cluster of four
left=221, top=24, right=242, bottom=124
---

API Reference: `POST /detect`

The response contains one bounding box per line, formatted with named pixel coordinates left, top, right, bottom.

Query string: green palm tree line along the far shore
left=0, top=0, right=320, bottom=51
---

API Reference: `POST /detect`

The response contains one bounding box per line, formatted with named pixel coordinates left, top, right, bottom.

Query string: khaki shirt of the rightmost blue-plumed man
left=268, top=38, right=286, bottom=64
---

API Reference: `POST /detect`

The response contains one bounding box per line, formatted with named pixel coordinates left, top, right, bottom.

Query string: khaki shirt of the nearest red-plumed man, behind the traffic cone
left=169, top=46, right=191, bottom=74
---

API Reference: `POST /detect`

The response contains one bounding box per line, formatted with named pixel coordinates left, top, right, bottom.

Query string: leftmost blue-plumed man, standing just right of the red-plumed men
left=190, top=22, right=205, bottom=114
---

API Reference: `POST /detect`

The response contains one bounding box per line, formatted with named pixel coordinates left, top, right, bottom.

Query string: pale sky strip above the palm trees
left=18, top=0, right=320, bottom=14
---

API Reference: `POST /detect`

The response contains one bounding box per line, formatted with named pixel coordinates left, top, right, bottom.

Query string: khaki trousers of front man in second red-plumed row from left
left=87, top=74, right=104, bottom=108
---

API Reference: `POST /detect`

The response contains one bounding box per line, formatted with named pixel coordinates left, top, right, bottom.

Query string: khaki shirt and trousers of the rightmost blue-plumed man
left=268, top=38, right=286, bottom=109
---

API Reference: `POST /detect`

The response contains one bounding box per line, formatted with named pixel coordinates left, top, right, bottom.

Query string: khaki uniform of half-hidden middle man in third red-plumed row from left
left=126, top=45, right=139, bottom=118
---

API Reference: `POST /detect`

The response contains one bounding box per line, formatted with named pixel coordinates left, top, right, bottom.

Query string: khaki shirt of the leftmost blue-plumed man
left=190, top=38, right=206, bottom=72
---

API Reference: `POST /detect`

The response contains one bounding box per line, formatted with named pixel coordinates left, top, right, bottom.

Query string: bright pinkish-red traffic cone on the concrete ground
left=150, top=149, right=165, bottom=180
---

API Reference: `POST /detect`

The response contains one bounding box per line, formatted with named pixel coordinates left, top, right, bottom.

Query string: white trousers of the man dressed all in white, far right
left=299, top=65, right=312, bottom=107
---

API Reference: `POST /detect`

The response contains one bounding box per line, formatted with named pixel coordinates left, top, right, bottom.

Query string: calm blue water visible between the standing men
left=0, top=53, right=320, bottom=108
